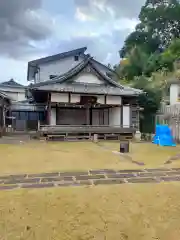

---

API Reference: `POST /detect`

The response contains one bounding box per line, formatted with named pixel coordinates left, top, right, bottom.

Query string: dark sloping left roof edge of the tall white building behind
left=28, top=47, right=87, bottom=66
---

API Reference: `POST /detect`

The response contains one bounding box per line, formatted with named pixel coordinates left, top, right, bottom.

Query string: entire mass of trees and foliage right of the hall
left=115, top=0, right=180, bottom=132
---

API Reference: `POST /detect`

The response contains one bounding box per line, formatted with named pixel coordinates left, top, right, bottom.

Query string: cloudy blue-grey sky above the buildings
left=0, top=0, right=145, bottom=84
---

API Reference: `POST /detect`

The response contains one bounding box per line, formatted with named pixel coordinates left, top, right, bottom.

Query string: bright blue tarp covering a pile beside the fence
left=152, top=125, right=176, bottom=147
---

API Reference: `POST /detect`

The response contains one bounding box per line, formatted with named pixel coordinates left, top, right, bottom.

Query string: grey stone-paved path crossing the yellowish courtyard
left=0, top=168, right=180, bottom=190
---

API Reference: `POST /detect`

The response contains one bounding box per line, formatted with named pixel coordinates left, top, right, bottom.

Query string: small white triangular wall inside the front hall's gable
left=74, top=73, right=103, bottom=84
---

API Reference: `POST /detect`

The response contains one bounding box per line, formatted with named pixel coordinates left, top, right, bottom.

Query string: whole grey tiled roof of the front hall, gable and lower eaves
left=29, top=56, right=140, bottom=95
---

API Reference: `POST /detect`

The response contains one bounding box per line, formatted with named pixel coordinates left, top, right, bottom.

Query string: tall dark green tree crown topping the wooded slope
left=120, top=0, right=180, bottom=58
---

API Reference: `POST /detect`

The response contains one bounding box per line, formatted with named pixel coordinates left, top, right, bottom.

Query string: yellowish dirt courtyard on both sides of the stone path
left=0, top=138, right=180, bottom=240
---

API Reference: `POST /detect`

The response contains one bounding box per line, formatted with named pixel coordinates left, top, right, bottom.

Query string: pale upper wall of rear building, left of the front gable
left=36, top=57, right=82, bottom=82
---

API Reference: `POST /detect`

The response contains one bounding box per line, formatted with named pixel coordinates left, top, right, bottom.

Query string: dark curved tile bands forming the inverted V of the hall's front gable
left=29, top=56, right=124, bottom=89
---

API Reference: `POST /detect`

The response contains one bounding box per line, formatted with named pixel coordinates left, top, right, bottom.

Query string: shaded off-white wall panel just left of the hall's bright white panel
left=109, top=107, right=121, bottom=126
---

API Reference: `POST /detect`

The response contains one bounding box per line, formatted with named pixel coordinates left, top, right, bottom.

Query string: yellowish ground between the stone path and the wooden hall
left=0, top=138, right=180, bottom=175
